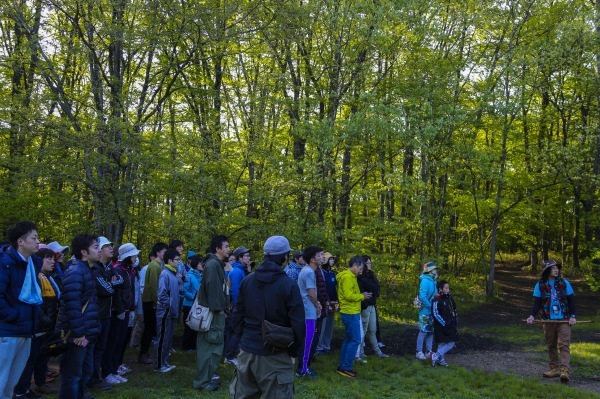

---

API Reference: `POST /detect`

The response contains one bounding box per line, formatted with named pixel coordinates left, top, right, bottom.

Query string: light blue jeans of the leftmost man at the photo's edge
left=0, top=337, right=31, bottom=399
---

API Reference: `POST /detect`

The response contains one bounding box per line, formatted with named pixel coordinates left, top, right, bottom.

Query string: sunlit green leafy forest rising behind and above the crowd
left=0, top=0, right=600, bottom=294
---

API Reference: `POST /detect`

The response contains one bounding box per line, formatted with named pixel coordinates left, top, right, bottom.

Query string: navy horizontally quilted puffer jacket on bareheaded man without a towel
left=58, top=260, right=100, bottom=343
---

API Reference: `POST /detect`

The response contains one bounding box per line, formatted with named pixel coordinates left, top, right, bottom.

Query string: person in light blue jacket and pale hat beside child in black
left=417, top=262, right=438, bottom=360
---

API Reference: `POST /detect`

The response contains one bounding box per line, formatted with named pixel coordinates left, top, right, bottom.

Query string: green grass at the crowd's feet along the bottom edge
left=94, top=344, right=600, bottom=399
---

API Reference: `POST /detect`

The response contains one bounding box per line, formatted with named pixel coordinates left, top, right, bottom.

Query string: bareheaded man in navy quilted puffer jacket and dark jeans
left=58, top=234, right=100, bottom=399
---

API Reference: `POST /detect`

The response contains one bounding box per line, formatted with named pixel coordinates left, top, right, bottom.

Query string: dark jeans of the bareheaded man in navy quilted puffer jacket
left=58, top=344, right=94, bottom=399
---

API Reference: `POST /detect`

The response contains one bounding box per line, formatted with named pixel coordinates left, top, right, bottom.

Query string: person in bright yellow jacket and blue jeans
left=337, top=256, right=373, bottom=378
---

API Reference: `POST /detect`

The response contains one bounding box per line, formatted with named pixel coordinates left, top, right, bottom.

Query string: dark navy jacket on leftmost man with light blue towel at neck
left=0, top=246, right=43, bottom=337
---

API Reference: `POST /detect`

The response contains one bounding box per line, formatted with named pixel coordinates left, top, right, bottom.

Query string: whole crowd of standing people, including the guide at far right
left=0, top=222, right=575, bottom=399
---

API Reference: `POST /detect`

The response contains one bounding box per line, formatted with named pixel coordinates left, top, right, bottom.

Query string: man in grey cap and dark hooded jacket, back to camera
left=229, top=236, right=305, bottom=398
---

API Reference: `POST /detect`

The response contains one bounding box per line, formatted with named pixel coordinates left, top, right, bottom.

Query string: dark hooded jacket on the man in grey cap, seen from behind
left=231, top=260, right=305, bottom=357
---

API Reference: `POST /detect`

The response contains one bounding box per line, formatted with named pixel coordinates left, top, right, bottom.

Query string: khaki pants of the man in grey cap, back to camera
left=229, top=351, right=294, bottom=399
